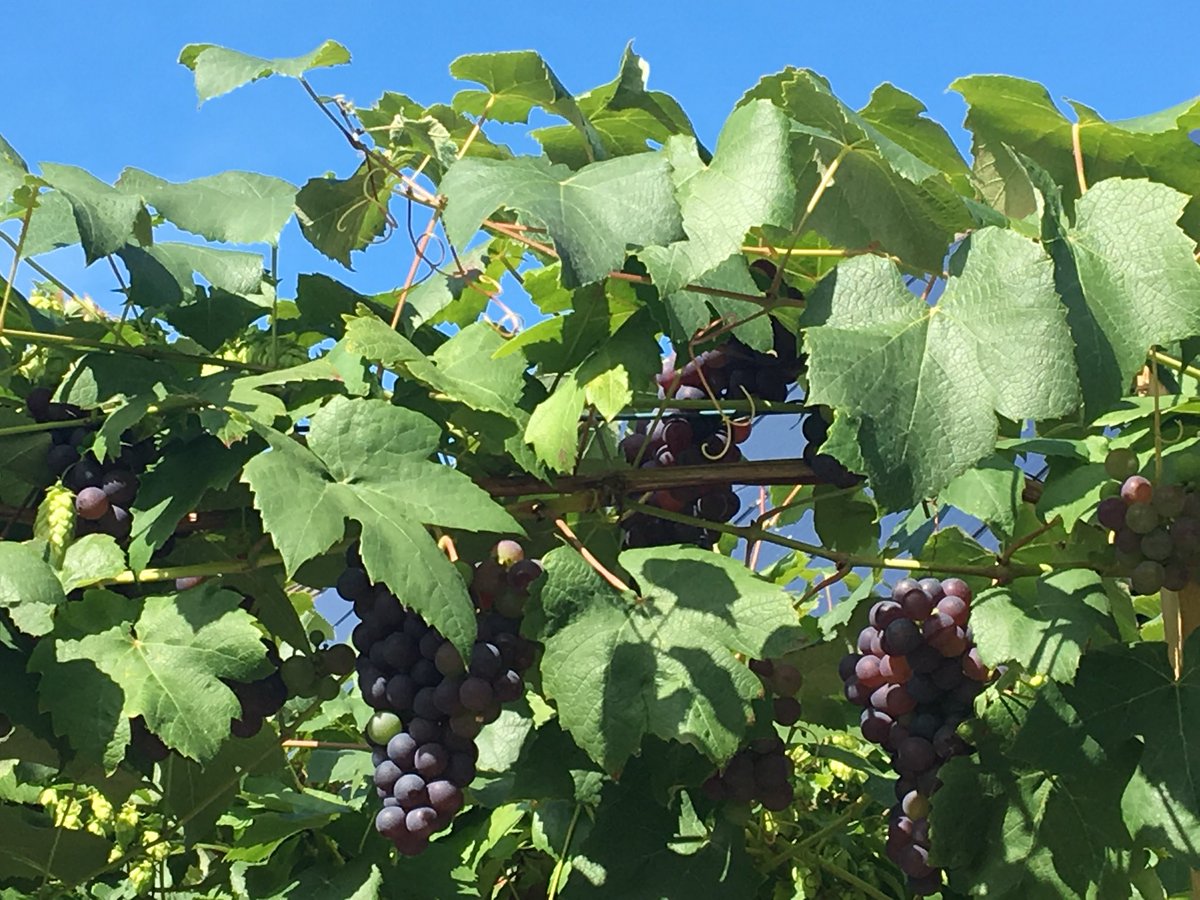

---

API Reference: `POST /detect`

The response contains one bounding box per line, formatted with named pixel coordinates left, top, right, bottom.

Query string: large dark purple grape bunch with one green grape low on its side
left=337, top=540, right=542, bottom=856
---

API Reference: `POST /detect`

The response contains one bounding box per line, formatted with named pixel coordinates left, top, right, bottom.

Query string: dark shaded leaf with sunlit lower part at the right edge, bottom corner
left=1067, top=632, right=1200, bottom=866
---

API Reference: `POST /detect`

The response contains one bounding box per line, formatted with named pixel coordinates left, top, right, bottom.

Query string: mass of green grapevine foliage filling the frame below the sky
left=0, top=41, right=1200, bottom=900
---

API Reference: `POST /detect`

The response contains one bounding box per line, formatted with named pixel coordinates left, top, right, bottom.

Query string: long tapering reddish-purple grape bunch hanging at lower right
left=839, top=578, right=990, bottom=895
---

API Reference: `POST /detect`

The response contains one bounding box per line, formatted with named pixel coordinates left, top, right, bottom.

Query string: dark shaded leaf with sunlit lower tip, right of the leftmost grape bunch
left=130, top=434, right=250, bottom=571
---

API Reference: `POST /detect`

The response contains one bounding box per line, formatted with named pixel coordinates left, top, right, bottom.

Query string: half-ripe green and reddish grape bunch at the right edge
left=1096, top=449, right=1200, bottom=594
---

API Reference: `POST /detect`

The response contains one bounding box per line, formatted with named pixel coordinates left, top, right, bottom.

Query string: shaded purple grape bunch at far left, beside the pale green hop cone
left=25, top=388, right=157, bottom=540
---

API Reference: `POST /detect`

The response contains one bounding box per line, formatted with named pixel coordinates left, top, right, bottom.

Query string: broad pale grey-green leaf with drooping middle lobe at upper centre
left=440, top=154, right=683, bottom=288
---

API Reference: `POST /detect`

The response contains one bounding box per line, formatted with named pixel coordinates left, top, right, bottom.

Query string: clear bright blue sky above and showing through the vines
left=0, top=0, right=1200, bottom=628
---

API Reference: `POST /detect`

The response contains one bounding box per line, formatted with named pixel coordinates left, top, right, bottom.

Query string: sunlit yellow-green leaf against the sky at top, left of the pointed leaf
left=450, top=50, right=605, bottom=162
